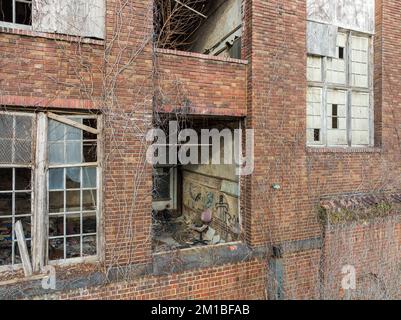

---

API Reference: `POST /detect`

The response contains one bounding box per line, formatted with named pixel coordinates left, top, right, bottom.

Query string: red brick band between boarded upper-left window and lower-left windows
left=0, top=28, right=104, bottom=99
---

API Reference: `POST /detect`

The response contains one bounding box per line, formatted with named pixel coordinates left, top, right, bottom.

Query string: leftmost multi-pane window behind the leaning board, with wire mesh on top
left=0, top=113, right=34, bottom=266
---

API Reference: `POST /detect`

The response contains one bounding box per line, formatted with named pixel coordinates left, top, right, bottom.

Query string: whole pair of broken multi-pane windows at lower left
left=0, top=112, right=99, bottom=266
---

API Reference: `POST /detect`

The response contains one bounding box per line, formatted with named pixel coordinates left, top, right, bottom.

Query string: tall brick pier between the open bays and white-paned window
left=245, top=1, right=319, bottom=244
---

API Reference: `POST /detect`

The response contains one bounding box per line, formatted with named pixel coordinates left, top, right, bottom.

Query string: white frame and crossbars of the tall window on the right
left=307, top=29, right=374, bottom=148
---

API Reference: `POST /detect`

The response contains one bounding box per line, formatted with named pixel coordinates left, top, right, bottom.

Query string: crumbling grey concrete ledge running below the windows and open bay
left=0, top=238, right=322, bottom=300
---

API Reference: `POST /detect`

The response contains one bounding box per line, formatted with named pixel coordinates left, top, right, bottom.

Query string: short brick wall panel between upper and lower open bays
left=156, top=49, right=246, bottom=116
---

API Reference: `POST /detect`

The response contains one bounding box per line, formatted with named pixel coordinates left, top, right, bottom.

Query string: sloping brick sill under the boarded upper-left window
left=0, top=24, right=105, bottom=46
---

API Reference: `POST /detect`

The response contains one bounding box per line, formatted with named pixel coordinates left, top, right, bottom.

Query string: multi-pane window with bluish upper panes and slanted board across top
left=48, top=116, right=98, bottom=260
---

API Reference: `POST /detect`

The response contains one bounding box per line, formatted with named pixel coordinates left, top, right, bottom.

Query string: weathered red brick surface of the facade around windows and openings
left=0, top=0, right=401, bottom=299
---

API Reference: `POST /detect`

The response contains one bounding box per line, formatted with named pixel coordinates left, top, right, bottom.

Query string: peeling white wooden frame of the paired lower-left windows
left=0, top=110, right=103, bottom=272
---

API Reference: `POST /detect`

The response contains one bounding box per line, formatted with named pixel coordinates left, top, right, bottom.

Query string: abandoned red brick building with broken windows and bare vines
left=0, top=0, right=401, bottom=299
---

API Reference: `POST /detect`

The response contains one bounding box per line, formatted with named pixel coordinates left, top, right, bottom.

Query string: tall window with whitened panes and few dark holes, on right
left=307, top=31, right=373, bottom=146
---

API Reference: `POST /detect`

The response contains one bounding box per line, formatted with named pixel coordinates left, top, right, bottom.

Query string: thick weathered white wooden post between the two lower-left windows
left=32, top=112, right=48, bottom=272
